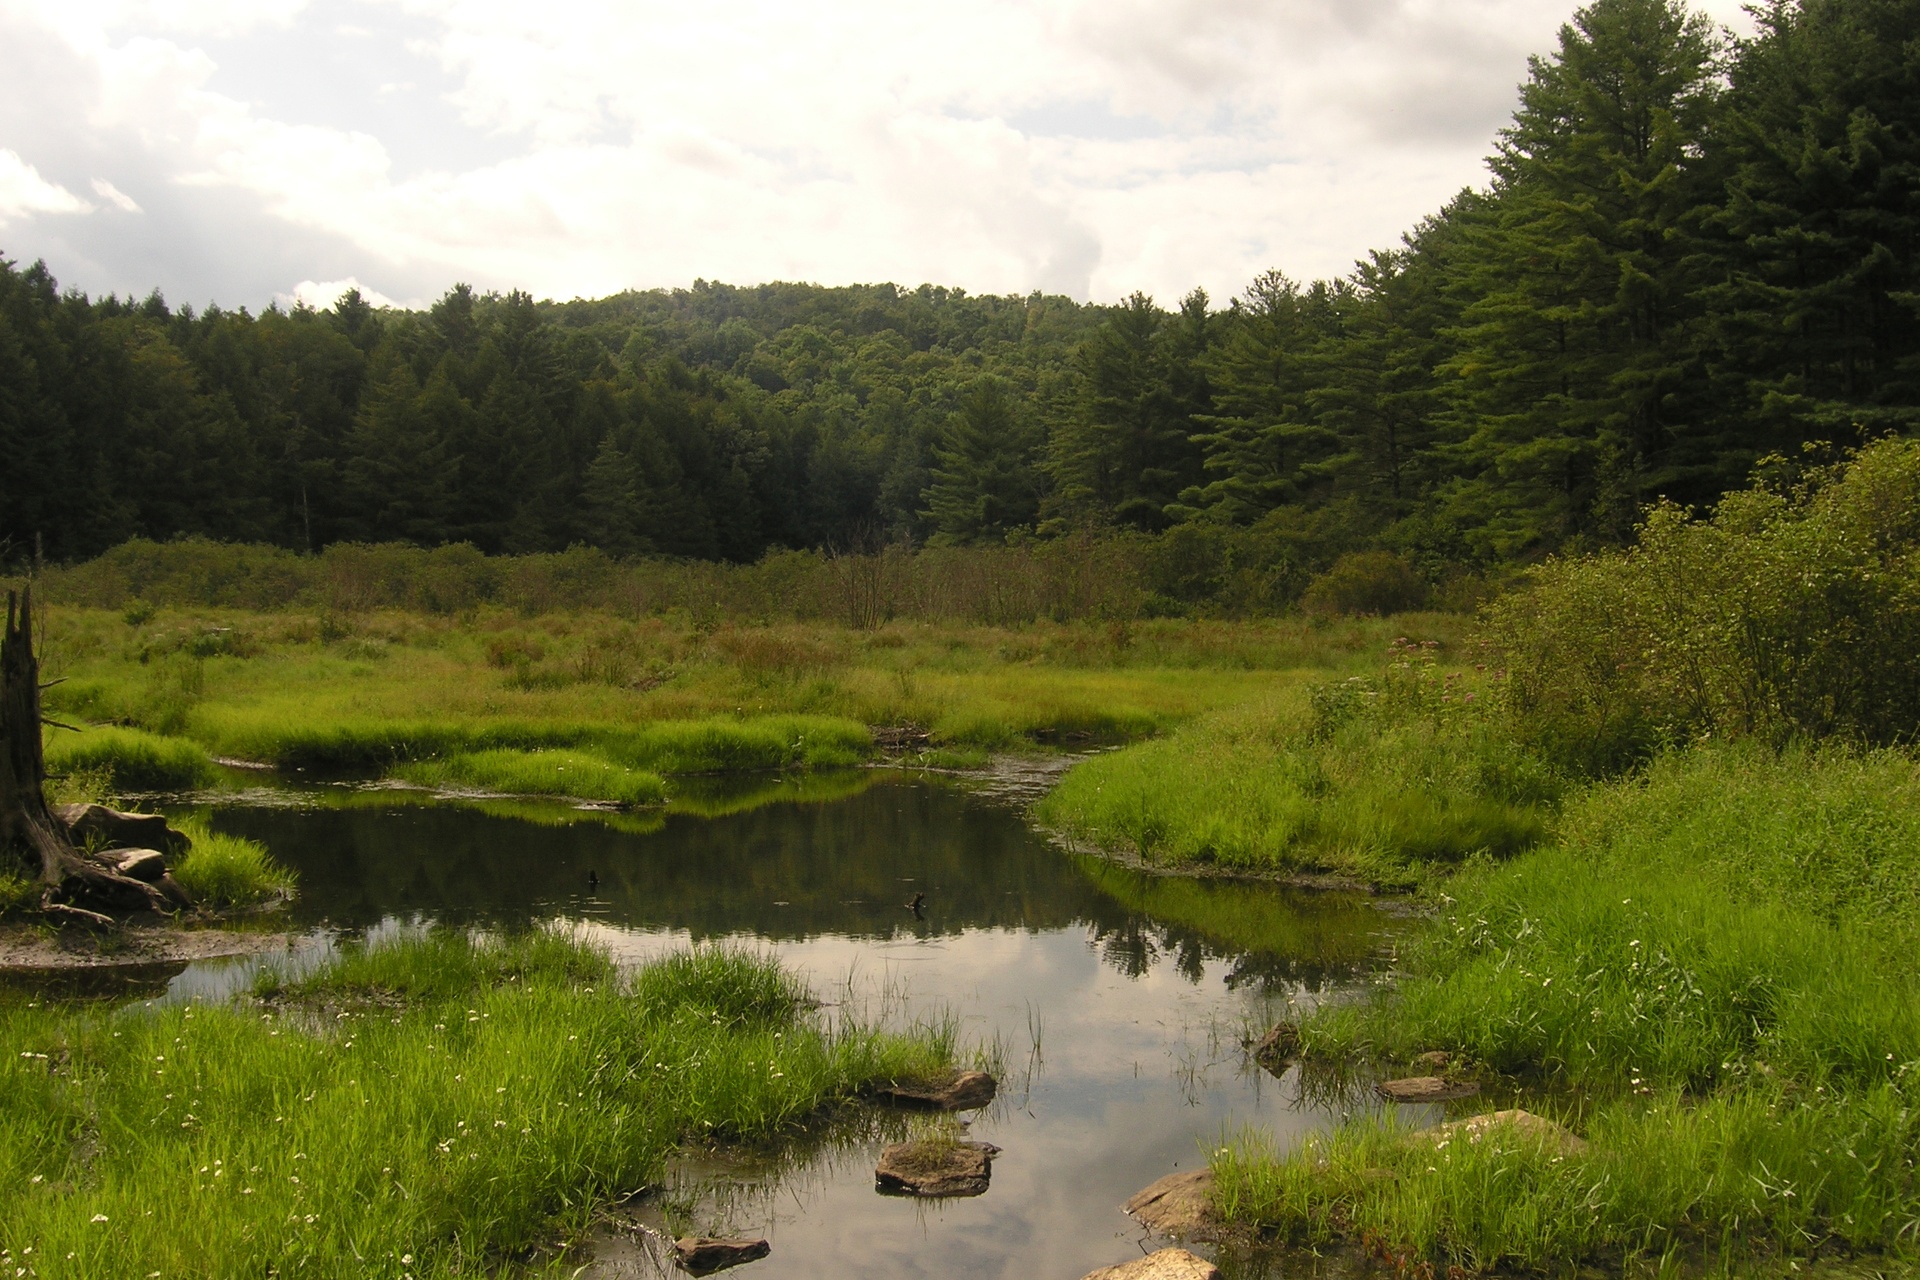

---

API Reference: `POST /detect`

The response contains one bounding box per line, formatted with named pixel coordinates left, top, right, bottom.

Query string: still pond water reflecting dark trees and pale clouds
left=167, top=773, right=1394, bottom=1280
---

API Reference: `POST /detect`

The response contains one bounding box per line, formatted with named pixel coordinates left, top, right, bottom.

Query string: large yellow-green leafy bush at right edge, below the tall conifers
left=1490, top=439, right=1920, bottom=770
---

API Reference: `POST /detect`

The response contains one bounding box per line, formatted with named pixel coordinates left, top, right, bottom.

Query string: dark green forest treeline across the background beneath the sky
left=0, top=0, right=1920, bottom=575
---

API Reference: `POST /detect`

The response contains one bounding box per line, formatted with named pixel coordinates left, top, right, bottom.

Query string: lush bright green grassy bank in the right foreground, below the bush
left=1215, top=745, right=1920, bottom=1268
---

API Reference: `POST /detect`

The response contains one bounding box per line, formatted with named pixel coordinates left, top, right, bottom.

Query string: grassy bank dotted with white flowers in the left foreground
left=0, top=935, right=952, bottom=1280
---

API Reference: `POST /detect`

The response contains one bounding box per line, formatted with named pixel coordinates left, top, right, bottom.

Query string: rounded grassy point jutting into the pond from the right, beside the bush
left=1037, top=681, right=1559, bottom=885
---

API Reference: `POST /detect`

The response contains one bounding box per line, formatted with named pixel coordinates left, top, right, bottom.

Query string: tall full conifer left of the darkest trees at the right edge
left=1450, top=0, right=1718, bottom=555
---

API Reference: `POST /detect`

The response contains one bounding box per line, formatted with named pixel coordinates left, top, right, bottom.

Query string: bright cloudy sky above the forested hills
left=0, top=0, right=1740, bottom=307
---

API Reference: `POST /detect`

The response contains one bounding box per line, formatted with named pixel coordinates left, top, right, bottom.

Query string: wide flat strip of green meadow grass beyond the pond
left=33, top=608, right=1461, bottom=775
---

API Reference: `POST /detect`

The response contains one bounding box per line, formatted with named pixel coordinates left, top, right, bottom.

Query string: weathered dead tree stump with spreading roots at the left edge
left=0, top=585, right=173, bottom=925
